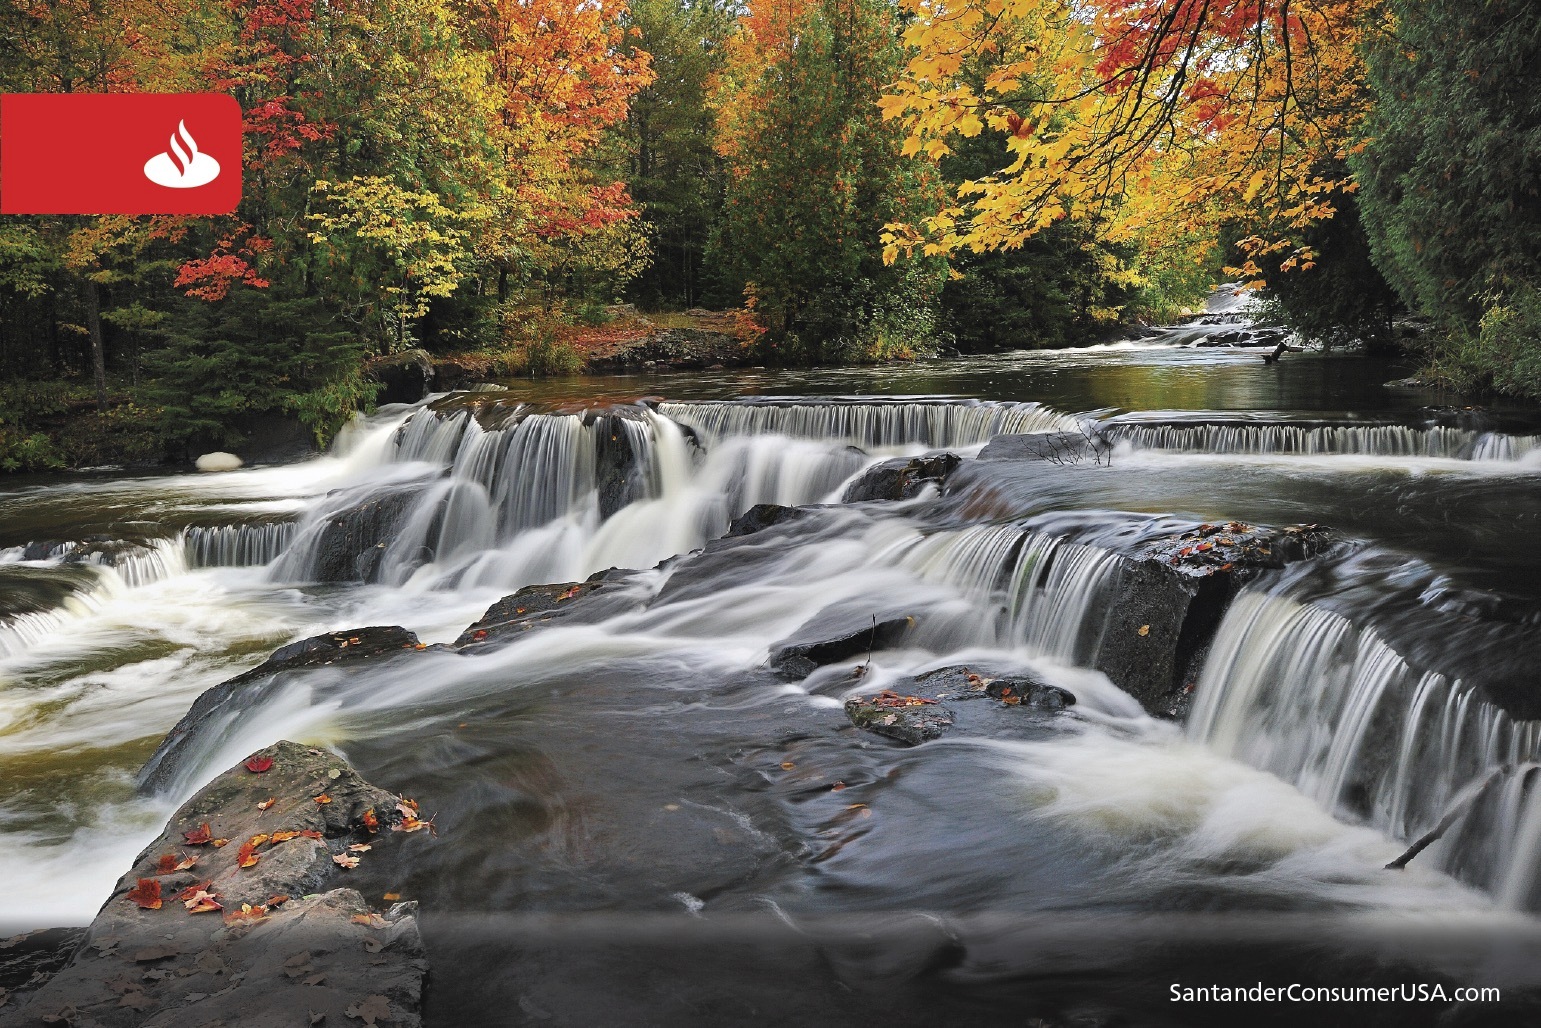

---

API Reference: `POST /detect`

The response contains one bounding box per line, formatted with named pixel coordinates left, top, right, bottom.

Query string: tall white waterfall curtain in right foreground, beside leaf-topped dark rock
left=1187, top=587, right=1541, bottom=908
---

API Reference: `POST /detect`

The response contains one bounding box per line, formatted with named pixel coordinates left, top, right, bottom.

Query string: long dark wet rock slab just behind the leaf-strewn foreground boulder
left=139, top=626, right=425, bottom=792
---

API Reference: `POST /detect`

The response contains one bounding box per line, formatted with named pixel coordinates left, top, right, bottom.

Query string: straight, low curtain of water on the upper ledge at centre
left=658, top=398, right=1080, bottom=448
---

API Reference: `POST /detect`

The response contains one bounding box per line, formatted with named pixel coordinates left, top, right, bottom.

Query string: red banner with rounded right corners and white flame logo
left=0, top=92, right=240, bottom=214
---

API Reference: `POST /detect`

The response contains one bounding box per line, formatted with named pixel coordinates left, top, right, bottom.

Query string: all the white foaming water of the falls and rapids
left=0, top=391, right=1541, bottom=943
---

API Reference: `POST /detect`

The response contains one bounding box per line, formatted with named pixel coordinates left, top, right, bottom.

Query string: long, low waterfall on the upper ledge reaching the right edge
left=1099, top=421, right=1541, bottom=461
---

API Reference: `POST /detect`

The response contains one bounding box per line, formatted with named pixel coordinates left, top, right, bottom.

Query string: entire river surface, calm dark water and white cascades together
left=0, top=330, right=1541, bottom=1025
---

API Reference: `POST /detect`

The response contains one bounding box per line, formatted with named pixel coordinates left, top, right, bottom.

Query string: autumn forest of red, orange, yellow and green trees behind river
left=0, top=0, right=1541, bottom=470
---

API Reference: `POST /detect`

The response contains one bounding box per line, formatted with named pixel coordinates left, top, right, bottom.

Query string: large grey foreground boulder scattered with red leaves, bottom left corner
left=6, top=741, right=427, bottom=1028
